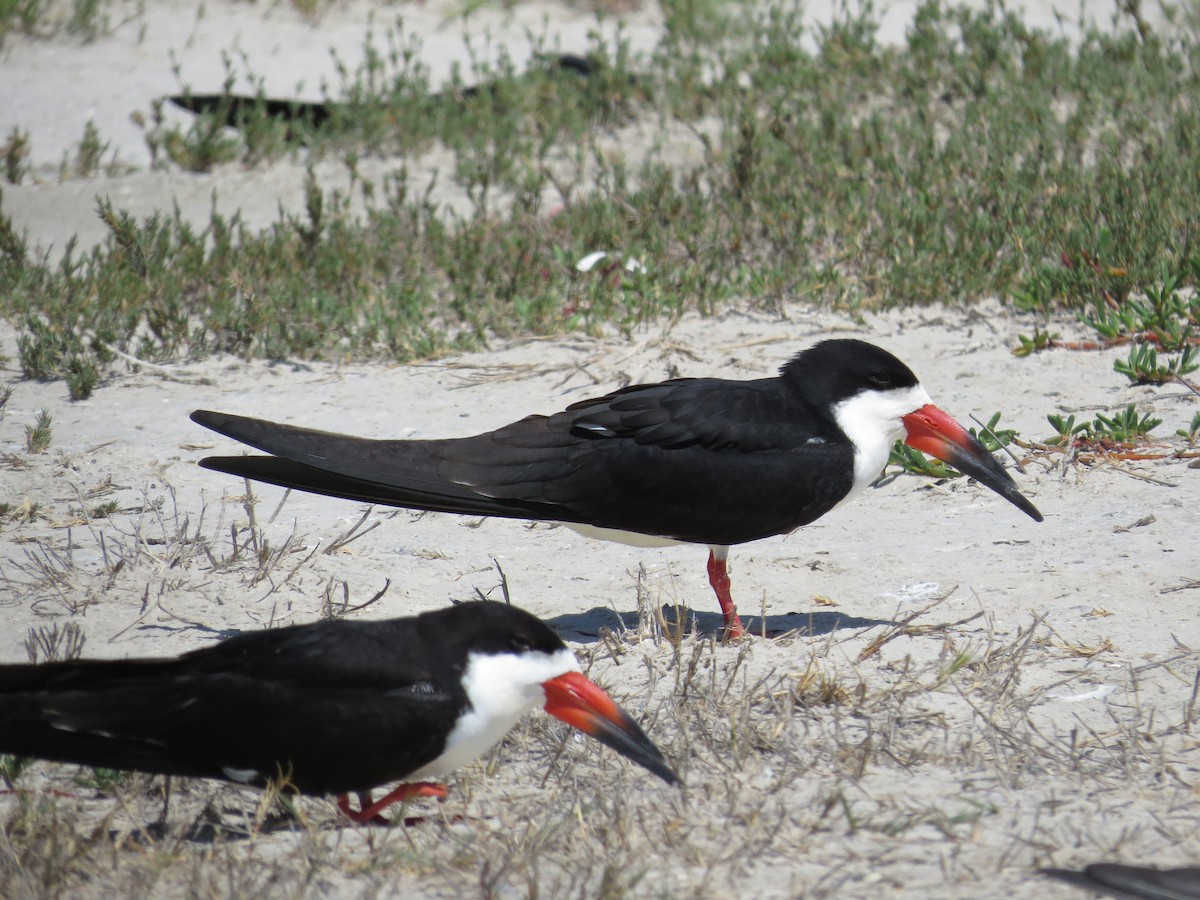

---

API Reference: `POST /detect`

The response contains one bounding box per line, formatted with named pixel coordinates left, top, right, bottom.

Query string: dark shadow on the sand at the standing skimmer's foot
left=546, top=605, right=894, bottom=643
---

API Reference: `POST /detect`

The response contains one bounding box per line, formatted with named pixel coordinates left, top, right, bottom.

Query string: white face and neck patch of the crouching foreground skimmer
left=406, top=647, right=580, bottom=781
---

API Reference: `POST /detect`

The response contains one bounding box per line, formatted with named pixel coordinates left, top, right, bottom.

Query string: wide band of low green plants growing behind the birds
left=0, top=4, right=1200, bottom=397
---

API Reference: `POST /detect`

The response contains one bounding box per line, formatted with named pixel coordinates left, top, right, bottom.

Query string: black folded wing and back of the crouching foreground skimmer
left=0, top=620, right=461, bottom=793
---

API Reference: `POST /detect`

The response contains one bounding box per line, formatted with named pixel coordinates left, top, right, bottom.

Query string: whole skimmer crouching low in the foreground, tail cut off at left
left=0, top=601, right=678, bottom=822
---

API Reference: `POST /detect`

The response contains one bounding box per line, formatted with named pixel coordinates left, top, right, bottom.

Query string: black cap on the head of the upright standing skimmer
left=780, top=338, right=918, bottom=408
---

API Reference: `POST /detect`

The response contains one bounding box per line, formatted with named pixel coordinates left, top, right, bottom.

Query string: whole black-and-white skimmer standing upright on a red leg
left=192, top=340, right=1042, bottom=636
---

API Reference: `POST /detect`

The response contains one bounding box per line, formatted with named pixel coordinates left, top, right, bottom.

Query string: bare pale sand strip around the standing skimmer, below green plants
left=0, top=297, right=1200, bottom=659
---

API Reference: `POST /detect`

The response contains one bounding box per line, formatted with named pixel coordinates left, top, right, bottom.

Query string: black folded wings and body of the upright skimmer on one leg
left=192, top=379, right=853, bottom=545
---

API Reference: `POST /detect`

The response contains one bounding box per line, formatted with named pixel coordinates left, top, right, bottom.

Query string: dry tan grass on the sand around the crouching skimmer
left=0, top=509, right=1198, bottom=898
